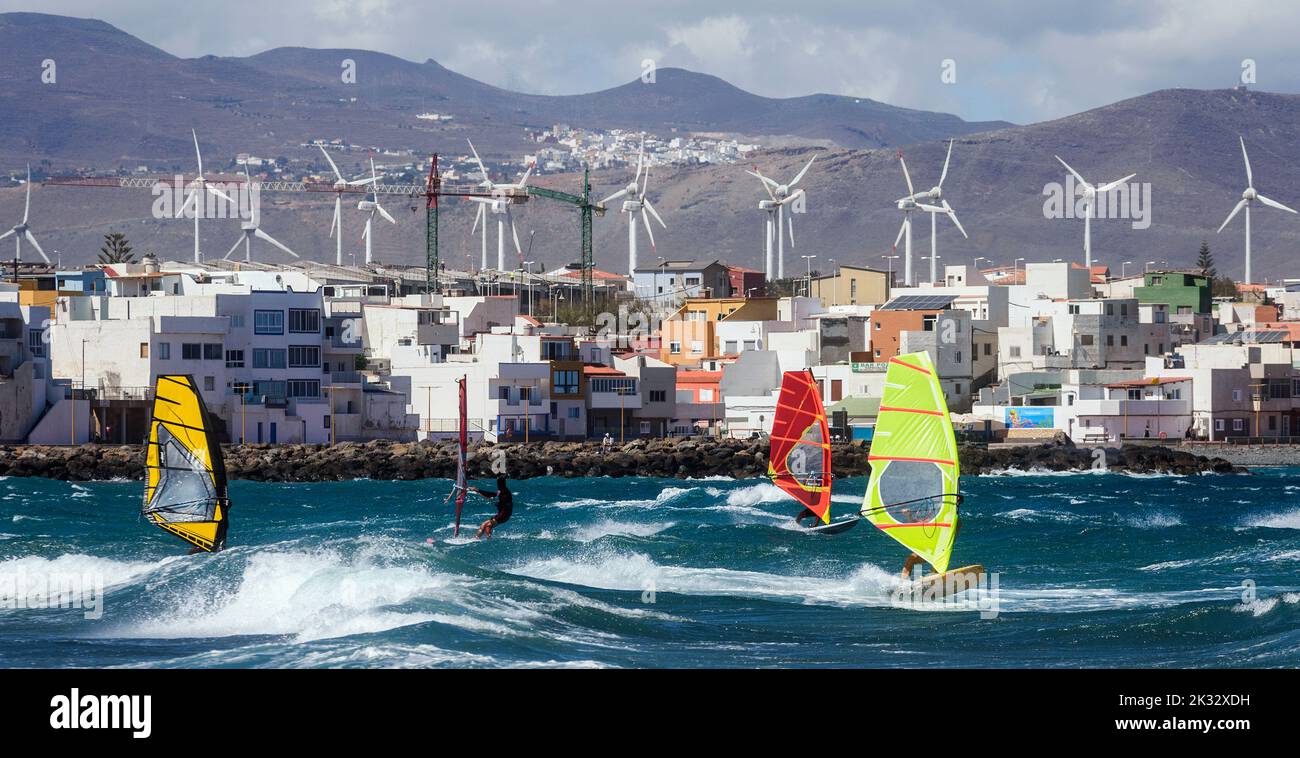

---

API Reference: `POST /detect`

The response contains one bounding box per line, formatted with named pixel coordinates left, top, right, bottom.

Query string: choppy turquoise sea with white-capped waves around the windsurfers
left=0, top=469, right=1300, bottom=667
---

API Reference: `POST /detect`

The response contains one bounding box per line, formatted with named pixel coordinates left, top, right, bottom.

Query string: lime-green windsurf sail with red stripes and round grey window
left=862, top=352, right=961, bottom=572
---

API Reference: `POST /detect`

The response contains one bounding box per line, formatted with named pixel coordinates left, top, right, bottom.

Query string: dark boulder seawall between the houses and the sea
left=0, top=438, right=1243, bottom=481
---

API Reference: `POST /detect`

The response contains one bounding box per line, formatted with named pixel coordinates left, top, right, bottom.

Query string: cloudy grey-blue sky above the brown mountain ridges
left=10, top=0, right=1300, bottom=124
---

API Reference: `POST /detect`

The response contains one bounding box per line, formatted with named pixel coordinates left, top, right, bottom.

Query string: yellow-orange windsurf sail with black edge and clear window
left=142, top=374, right=230, bottom=553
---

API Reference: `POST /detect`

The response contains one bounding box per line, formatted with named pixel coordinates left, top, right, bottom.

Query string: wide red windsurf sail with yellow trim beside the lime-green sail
left=767, top=371, right=831, bottom=524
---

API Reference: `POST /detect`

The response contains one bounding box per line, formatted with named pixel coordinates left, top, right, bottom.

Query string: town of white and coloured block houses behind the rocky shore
left=0, top=247, right=1300, bottom=445
